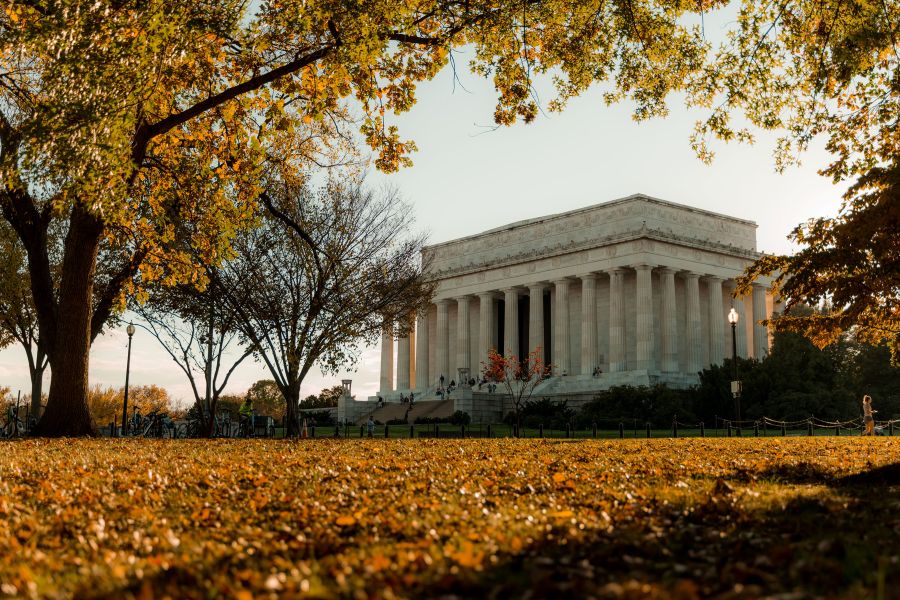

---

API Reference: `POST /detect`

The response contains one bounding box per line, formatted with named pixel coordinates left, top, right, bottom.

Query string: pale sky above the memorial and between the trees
left=0, top=24, right=845, bottom=402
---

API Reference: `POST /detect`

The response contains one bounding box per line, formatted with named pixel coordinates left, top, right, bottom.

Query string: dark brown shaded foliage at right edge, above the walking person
left=742, top=157, right=900, bottom=365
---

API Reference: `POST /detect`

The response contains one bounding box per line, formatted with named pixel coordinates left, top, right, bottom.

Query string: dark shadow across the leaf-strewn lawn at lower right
left=85, top=463, right=900, bottom=600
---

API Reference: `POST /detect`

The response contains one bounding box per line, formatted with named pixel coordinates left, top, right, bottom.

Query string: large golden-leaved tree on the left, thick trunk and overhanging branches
left=0, top=0, right=736, bottom=435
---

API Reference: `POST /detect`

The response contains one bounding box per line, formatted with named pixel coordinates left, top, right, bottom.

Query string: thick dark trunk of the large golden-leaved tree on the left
left=35, top=207, right=103, bottom=437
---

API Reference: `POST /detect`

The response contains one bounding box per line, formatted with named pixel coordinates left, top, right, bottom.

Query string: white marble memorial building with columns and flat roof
left=356, top=194, right=774, bottom=422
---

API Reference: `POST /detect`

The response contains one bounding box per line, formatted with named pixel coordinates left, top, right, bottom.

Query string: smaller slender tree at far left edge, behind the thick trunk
left=0, top=222, right=49, bottom=419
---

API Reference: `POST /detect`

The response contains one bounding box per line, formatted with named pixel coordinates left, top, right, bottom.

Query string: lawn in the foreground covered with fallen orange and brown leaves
left=0, top=437, right=900, bottom=600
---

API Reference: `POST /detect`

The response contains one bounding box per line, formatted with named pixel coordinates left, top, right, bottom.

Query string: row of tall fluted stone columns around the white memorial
left=381, top=264, right=768, bottom=392
